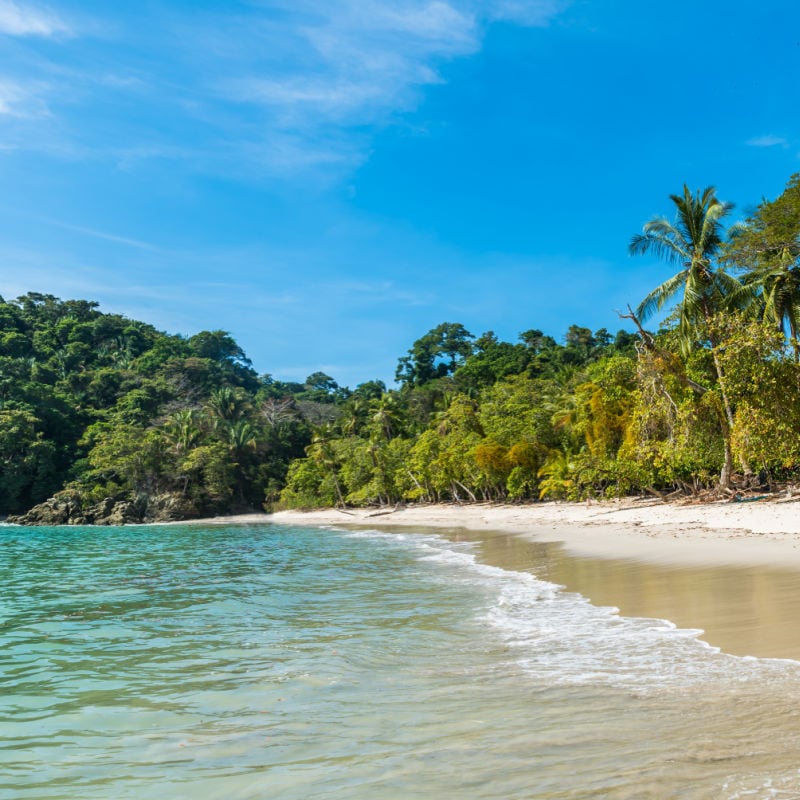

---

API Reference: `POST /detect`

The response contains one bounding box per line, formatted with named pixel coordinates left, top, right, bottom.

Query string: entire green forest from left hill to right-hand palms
left=0, top=175, right=800, bottom=524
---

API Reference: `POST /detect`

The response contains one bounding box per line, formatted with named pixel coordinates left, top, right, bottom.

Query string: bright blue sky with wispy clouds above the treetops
left=0, top=0, right=800, bottom=386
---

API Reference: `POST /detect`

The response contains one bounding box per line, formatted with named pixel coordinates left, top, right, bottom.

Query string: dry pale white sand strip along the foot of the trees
left=256, top=499, right=800, bottom=568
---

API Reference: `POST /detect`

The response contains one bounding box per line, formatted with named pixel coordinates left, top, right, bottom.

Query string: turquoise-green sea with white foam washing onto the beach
left=0, top=525, right=800, bottom=800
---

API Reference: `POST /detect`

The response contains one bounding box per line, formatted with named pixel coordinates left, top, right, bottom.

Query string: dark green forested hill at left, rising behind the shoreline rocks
left=0, top=294, right=322, bottom=522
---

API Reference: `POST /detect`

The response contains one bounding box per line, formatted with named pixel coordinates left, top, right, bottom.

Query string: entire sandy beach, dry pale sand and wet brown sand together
left=220, top=500, right=800, bottom=661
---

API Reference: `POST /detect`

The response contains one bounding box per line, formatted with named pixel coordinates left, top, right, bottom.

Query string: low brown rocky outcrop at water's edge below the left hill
left=7, top=489, right=200, bottom=525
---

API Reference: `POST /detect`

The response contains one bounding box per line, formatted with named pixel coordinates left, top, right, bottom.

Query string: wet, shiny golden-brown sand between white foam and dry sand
left=455, top=531, right=800, bottom=660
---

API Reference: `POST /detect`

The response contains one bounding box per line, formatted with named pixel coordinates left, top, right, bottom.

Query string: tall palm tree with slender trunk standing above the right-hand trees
left=629, top=184, right=750, bottom=488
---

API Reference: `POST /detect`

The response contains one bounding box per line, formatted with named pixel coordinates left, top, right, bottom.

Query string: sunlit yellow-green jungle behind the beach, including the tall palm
left=281, top=175, right=800, bottom=507
